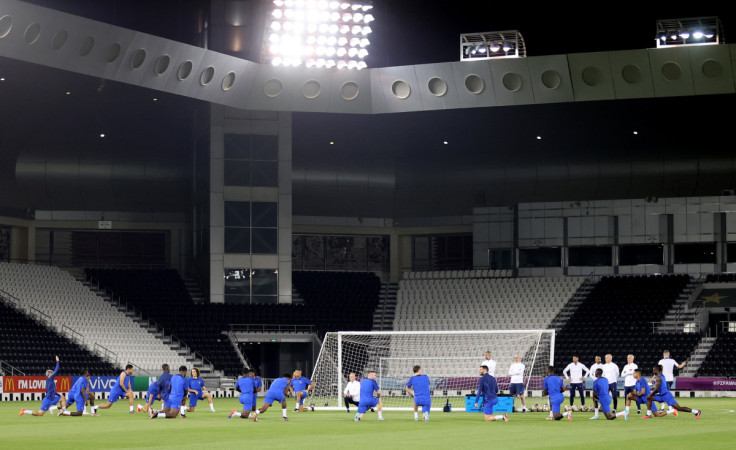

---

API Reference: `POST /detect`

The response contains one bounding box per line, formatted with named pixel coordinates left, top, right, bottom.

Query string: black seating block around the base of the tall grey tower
left=87, top=269, right=380, bottom=376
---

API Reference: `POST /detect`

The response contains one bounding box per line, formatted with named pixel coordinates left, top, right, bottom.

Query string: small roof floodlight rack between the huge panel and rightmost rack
left=460, top=30, right=526, bottom=61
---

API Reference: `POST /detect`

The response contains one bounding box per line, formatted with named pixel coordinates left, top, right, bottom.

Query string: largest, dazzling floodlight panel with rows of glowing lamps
left=263, top=0, right=374, bottom=69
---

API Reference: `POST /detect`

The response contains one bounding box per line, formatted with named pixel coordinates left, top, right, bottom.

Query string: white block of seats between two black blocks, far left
left=0, top=263, right=186, bottom=373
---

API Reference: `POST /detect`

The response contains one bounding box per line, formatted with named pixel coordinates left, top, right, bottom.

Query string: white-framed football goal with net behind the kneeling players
left=311, top=330, right=555, bottom=410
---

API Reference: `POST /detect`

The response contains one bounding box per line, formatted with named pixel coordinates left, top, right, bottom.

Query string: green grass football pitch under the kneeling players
left=0, top=398, right=736, bottom=449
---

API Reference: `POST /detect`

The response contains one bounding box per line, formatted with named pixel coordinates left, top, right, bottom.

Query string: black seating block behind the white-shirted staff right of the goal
left=555, top=275, right=701, bottom=371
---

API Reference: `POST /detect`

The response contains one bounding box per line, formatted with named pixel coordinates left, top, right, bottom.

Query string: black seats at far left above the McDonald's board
left=0, top=295, right=117, bottom=375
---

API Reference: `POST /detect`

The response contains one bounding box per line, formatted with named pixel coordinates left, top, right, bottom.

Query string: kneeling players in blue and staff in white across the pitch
left=19, top=350, right=701, bottom=422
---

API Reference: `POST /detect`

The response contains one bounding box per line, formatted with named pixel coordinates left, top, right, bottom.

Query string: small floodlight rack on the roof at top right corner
left=655, top=16, right=725, bottom=48
